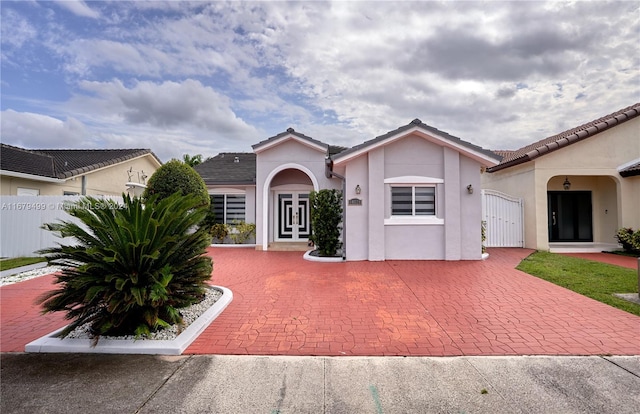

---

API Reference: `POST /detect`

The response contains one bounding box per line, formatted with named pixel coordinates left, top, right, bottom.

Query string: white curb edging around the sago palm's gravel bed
left=24, top=286, right=233, bottom=355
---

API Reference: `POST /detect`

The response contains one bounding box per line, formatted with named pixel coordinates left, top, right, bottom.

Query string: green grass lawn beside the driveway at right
left=517, top=252, right=640, bottom=316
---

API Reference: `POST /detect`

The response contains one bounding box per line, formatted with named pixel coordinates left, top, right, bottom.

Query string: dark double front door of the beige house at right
left=547, top=191, right=593, bottom=242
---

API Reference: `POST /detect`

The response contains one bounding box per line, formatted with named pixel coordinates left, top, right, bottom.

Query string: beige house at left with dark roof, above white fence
left=0, top=144, right=162, bottom=195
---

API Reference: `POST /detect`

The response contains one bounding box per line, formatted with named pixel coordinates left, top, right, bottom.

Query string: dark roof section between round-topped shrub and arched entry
left=195, top=152, right=256, bottom=185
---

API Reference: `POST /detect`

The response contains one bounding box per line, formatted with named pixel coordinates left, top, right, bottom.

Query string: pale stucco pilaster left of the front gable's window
left=368, top=148, right=385, bottom=261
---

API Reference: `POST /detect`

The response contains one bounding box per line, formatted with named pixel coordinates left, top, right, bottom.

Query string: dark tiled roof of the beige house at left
left=0, top=144, right=162, bottom=180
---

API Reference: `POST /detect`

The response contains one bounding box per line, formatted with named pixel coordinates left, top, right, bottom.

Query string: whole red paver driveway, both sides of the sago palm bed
left=0, top=248, right=640, bottom=356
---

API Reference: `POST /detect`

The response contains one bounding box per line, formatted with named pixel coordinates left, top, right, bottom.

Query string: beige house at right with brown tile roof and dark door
left=482, top=103, right=640, bottom=251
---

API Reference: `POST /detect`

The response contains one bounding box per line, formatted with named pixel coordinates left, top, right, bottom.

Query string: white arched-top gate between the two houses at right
left=482, top=190, right=524, bottom=247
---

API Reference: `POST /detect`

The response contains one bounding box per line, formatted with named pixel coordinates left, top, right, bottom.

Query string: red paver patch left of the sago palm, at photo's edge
left=0, top=275, right=69, bottom=352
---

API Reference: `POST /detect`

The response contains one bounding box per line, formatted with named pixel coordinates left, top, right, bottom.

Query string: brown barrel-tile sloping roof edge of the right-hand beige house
left=487, top=103, right=640, bottom=172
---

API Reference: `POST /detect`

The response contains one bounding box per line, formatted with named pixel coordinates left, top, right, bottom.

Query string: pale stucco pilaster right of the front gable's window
left=444, top=147, right=462, bottom=260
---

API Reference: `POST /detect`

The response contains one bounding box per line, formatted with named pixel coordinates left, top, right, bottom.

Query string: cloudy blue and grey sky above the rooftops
left=1, top=1, right=640, bottom=161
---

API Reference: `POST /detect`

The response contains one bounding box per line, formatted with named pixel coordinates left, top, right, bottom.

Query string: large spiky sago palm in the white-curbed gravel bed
left=39, top=194, right=212, bottom=338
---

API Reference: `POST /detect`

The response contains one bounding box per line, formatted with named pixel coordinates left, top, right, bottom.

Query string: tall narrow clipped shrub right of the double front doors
left=309, top=190, right=342, bottom=256
